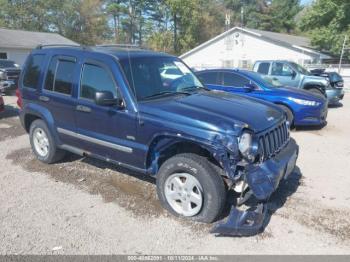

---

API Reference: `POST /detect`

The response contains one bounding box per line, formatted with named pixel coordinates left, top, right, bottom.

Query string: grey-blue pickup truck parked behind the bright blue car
left=254, top=61, right=344, bottom=105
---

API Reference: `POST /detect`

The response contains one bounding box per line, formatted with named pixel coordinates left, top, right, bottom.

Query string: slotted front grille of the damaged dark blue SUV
left=259, top=122, right=290, bottom=161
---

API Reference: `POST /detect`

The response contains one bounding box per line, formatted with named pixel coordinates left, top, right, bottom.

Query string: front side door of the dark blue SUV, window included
left=75, top=55, right=136, bottom=164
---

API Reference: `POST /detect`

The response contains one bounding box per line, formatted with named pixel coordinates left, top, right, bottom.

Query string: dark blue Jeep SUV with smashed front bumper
left=19, top=47, right=298, bottom=235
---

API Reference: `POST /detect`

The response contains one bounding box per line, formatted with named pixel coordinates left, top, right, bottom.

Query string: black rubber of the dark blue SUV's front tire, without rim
left=157, top=153, right=226, bottom=223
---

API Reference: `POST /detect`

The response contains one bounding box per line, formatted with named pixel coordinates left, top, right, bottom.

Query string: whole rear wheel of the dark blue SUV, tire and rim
left=29, top=119, right=65, bottom=164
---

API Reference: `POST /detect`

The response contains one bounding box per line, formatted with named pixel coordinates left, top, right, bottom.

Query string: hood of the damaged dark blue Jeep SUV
left=139, top=91, right=284, bottom=133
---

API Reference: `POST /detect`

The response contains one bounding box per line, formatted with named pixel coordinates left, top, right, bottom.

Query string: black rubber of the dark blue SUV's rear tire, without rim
left=29, top=119, right=65, bottom=164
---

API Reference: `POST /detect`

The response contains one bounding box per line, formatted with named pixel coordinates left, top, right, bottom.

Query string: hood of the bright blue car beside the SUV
left=270, top=87, right=326, bottom=103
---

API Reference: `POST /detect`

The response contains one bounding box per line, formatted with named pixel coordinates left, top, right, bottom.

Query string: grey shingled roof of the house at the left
left=0, top=28, right=77, bottom=49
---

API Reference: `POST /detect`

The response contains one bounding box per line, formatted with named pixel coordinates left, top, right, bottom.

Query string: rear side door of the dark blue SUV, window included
left=39, top=55, right=80, bottom=146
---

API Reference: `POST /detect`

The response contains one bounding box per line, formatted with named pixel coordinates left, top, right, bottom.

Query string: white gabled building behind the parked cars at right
left=180, top=27, right=331, bottom=69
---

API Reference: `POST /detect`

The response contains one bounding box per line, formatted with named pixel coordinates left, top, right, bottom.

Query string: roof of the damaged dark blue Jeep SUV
left=33, top=46, right=174, bottom=60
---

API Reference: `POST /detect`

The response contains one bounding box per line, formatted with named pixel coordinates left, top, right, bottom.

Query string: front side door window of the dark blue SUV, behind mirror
left=80, top=64, right=117, bottom=100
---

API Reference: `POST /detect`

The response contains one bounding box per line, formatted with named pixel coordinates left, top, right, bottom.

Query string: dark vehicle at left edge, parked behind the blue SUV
left=0, top=59, right=21, bottom=93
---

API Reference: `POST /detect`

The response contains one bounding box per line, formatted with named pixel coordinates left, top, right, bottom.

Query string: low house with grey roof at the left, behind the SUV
left=0, top=28, right=77, bottom=65
